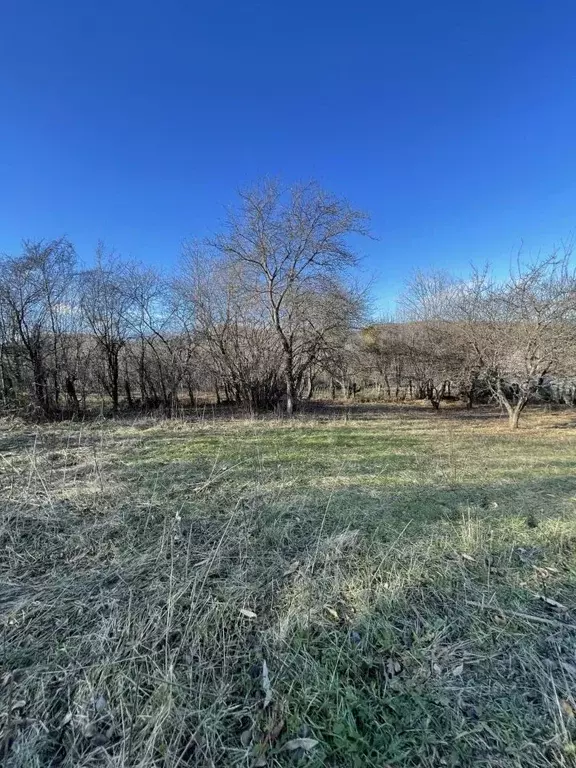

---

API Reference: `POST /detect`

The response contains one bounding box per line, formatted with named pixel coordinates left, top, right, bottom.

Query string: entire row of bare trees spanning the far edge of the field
left=0, top=182, right=576, bottom=427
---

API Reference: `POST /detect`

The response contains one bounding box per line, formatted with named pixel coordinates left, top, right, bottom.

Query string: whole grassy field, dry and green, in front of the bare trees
left=0, top=406, right=576, bottom=768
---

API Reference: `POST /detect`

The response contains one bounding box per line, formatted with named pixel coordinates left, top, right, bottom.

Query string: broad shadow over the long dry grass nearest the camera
left=0, top=462, right=576, bottom=768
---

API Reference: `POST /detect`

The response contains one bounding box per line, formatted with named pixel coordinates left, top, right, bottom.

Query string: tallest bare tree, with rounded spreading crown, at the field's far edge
left=212, top=182, right=367, bottom=414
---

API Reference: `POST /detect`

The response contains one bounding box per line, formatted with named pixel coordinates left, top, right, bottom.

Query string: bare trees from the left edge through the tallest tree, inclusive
left=0, top=182, right=366, bottom=418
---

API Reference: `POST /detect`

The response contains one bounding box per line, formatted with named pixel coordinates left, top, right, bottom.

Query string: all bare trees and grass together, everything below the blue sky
left=0, top=182, right=576, bottom=768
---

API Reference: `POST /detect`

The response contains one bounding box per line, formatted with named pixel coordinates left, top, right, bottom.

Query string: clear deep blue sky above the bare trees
left=0, top=0, right=576, bottom=303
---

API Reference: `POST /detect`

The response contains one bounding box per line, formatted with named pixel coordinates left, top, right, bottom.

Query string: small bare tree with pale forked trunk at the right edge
left=457, top=255, right=576, bottom=429
